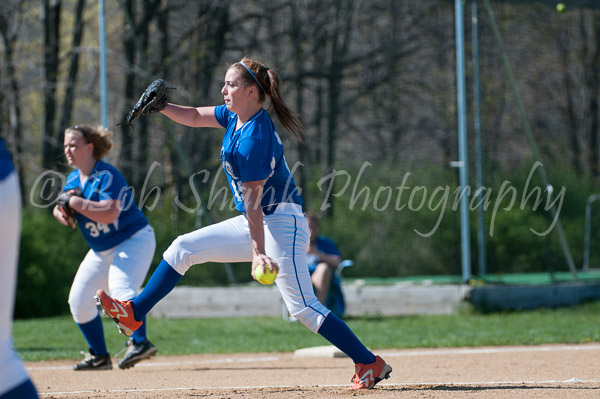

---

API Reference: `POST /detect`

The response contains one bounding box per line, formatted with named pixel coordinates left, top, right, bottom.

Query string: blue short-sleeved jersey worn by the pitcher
left=215, top=105, right=302, bottom=215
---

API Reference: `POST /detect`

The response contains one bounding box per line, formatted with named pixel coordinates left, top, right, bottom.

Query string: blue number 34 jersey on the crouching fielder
left=63, top=161, right=148, bottom=251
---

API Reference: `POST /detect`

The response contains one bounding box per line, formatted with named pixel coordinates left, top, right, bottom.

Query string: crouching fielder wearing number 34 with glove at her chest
left=53, top=126, right=156, bottom=370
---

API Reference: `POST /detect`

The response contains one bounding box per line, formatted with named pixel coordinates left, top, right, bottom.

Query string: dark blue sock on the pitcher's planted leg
left=318, top=313, right=375, bottom=364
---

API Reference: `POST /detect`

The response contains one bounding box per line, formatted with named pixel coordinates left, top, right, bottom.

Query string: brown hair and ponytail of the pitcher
left=231, top=57, right=304, bottom=142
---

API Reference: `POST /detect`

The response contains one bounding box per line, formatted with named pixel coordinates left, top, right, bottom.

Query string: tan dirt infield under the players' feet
left=26, top=344, right=600, bottom=399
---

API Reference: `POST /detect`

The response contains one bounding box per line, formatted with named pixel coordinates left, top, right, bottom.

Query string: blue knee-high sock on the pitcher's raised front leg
left=132, top=259, right=183, bottom=321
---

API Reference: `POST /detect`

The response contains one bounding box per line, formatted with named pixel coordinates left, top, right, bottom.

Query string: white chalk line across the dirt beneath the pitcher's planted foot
left=39, top=378, right=600, bottom=396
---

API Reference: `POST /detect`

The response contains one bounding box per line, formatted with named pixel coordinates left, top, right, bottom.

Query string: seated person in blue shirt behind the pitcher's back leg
left=306, top=212, right=342, bottom=305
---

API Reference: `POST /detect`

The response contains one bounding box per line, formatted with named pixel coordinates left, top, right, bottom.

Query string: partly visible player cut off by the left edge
left=0, top=137, right=38, bottom=399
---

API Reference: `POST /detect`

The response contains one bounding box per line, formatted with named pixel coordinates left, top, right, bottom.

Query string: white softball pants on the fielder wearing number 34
left=69, top=225, right=156, bottom=324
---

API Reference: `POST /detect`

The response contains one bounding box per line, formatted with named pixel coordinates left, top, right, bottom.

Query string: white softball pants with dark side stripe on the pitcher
left=163, top=204, right=329, bottom=333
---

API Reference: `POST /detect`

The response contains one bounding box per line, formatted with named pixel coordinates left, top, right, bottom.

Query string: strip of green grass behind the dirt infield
left=13, top=302, right=600, bottom=361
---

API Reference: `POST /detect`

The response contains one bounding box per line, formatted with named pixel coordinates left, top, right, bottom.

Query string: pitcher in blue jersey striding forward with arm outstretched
left=97, top=58, right=392, bottom=389
